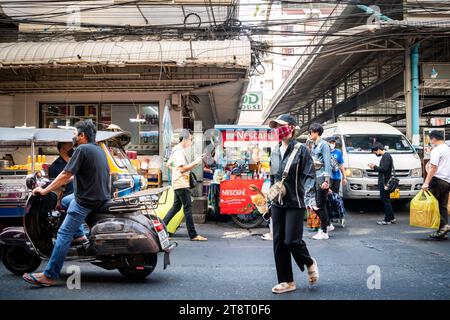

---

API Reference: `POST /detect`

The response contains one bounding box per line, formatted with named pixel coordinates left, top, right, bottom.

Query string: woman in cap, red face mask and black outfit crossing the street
left=270, top=114, right=319, bottom=293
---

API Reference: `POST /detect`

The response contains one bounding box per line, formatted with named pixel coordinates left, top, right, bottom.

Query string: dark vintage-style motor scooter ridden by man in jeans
left=0, top=172, right=177, bottom=279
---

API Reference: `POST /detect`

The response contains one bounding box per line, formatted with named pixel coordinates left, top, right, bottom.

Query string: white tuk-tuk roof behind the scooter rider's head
left=0, top=128, right=131, bottom=146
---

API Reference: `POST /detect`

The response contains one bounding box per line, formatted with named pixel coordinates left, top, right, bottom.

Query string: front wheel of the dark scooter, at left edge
left=2, top=246, right=41, bottom=276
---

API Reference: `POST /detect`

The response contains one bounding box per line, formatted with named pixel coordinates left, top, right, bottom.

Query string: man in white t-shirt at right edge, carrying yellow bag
left=422, top=131, right=450, bottom=239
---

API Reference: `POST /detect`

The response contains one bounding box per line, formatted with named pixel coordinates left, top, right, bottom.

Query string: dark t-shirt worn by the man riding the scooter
left=64, top=143, right=111, bottom=209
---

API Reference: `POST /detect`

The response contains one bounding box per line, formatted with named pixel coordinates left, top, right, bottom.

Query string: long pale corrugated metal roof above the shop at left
left=0, top=40, right=251, bottom=69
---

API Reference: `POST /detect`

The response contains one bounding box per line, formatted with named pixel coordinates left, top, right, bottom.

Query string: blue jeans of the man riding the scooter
left=44, top=200, right=92, bottom=279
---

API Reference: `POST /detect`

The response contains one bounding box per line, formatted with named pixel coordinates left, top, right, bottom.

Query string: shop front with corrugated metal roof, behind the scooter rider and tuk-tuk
left=0, top=40, right=251, bottom=196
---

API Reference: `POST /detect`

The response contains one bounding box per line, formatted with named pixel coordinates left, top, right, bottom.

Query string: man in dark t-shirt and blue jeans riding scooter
left=23, top=120, right=111, bottom=287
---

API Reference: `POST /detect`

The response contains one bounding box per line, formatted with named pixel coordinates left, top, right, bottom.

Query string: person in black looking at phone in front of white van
left=369, top=142, right=397, bottom=225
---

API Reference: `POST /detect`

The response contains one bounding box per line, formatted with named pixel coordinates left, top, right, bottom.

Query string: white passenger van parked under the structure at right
left=322, top=121, right=423, bottom=199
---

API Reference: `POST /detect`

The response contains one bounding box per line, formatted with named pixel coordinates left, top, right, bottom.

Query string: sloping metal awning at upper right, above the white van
left=263, top=1, right=404, bottom=123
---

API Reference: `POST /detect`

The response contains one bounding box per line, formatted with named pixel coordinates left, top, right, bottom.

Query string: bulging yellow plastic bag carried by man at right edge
left=409, top=190, right=440, bottom=229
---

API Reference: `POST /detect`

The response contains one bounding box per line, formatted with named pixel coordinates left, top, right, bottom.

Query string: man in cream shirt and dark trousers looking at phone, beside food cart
left=164, top=129, right=208, bottom=241
